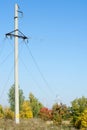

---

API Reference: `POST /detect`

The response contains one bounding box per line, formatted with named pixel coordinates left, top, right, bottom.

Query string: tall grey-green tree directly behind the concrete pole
left=8, top=85, right=25, bottom=111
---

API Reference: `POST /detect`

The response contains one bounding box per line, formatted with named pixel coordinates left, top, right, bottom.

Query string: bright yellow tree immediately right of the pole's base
left=20, top=101, right=33, bottom=119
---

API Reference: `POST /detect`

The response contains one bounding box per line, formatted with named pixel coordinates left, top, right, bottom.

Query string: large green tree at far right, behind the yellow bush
left=70, top=96, right=87, bottom=126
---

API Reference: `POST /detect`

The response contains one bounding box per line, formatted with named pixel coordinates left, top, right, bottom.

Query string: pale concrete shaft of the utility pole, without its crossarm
left=14, top=4, right=19, bottom=124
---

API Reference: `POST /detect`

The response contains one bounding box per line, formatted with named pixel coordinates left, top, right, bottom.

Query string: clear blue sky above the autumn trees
left=0, top=0, right=87, bottom=107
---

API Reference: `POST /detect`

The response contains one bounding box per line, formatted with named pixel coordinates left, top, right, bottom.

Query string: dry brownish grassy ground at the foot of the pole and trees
left=0, top=119, right=75, bottom=130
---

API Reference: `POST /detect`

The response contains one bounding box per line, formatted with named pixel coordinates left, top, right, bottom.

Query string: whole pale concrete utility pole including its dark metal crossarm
left=5, top=4, right=28, bottom=124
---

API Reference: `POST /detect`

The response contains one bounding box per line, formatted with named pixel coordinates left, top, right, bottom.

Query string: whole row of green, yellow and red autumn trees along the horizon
left=0, top=85, right=87, bottom=129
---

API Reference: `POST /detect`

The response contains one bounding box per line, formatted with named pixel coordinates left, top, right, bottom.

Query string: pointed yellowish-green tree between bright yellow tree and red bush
left=29, top=93, right=43, bottom=117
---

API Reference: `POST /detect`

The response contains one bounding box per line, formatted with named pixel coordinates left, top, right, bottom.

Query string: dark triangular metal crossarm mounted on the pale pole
left=5, top=29, right=28, bottom=40
